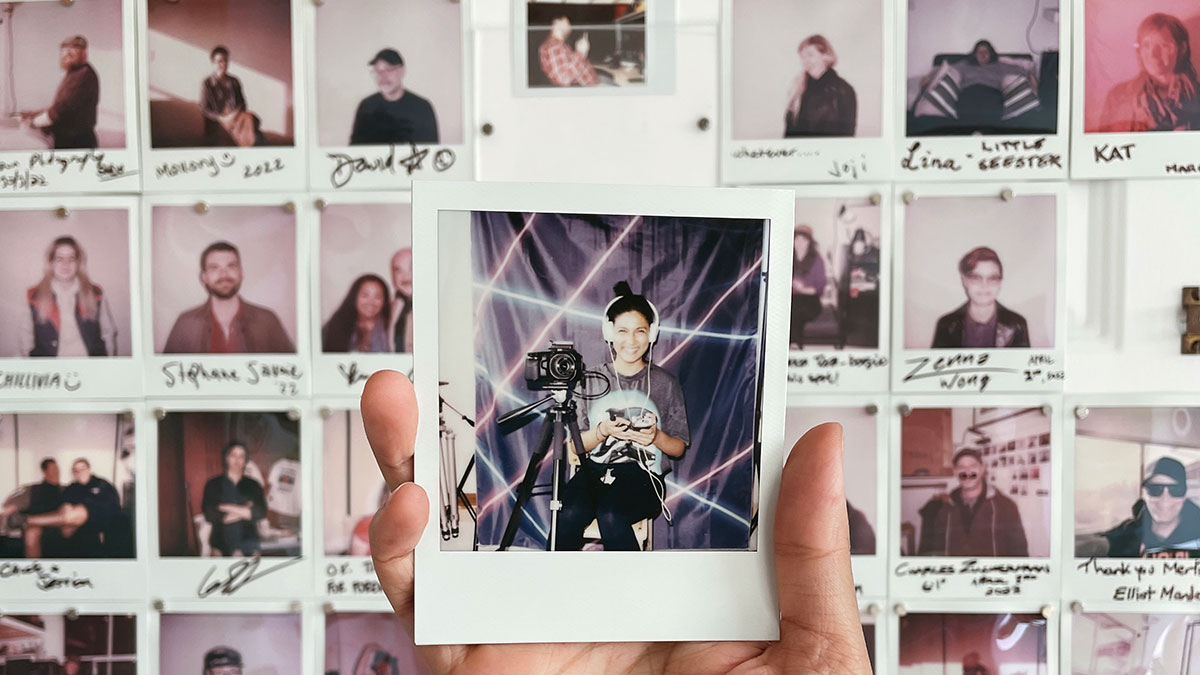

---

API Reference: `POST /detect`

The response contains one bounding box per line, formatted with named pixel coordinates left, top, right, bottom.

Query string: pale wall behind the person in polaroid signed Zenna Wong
left=896, top=196, right=1058, bottom=350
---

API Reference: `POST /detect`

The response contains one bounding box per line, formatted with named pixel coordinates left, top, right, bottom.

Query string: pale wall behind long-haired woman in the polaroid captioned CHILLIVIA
left=0, top=207, right=132, bottom=357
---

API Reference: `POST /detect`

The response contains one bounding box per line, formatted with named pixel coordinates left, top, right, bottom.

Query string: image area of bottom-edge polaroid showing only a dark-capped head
left=156, top=613, right=307, bottom=675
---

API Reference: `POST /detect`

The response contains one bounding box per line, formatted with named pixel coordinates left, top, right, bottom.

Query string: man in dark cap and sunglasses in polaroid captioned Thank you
left=1104, top=458, right=1200, bottom=557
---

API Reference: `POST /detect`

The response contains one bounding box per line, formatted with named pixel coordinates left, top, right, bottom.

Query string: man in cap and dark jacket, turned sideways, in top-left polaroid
left=24, top=35, right=100, bottom=150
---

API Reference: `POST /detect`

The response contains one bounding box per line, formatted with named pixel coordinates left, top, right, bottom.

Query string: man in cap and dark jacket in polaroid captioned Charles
left=917, top=448, right=1030, bottom=557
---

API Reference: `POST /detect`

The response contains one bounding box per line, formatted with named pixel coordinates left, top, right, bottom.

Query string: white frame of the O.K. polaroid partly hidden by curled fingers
left=307, top=398, right=386, bottom=598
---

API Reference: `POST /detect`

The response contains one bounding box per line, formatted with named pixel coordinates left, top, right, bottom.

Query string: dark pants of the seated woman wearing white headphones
left=556, top=460, right=662, bottom=551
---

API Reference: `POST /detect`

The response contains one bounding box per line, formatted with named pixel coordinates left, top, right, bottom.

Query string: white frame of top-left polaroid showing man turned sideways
left=0, top=0, right=140, bottom=195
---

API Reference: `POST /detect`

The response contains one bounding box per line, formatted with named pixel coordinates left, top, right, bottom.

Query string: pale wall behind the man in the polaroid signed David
left=314, top=0, right=464, bottom=147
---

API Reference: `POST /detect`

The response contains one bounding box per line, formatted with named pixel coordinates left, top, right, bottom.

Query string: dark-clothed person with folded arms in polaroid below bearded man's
left=200, top=441, right=266, bottom=557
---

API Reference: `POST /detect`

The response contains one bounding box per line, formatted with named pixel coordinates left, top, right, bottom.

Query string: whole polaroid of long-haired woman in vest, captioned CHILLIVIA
left=0, top=197, right=142, bottom=400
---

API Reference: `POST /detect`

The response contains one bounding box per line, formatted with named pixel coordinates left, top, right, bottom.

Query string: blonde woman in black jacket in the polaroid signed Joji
left=784, top=35, right=858, bottom=138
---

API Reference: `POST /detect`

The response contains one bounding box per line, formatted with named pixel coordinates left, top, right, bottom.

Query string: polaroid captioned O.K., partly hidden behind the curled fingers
left=317, top=407, right=388, bottom=597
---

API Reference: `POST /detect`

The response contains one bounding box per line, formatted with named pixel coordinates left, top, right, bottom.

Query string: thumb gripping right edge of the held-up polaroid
left=775, top=424, right=871, bottom=673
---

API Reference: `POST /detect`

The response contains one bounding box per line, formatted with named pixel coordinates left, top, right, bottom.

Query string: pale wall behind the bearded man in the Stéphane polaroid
left=150, top=205, right=300, bottom=353
